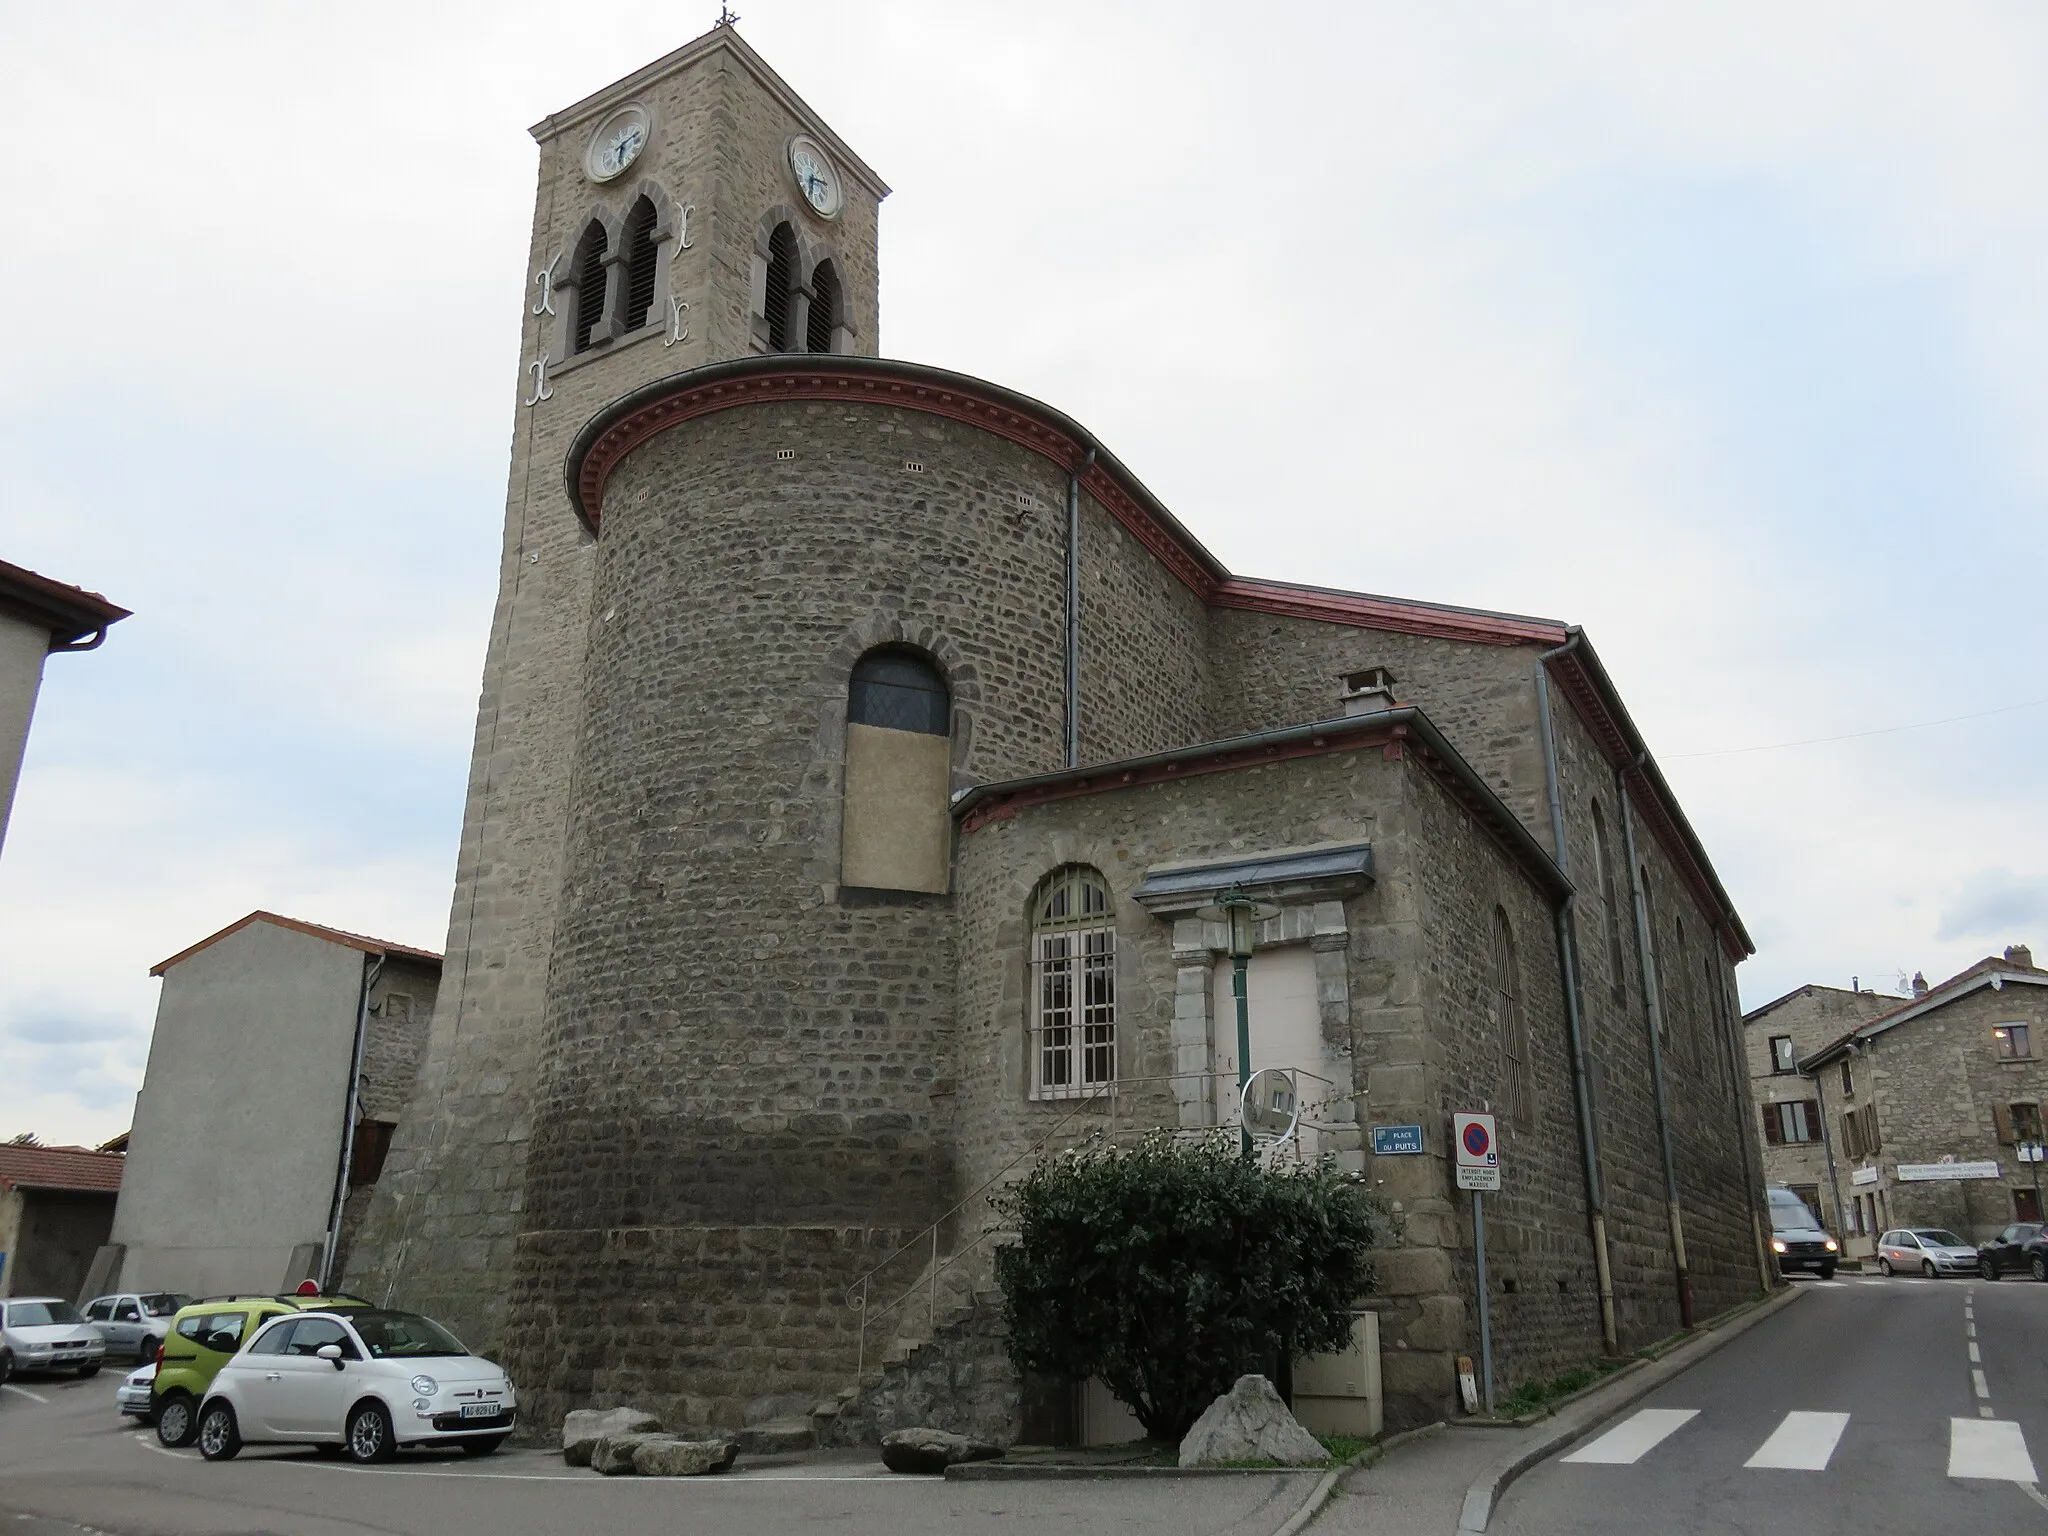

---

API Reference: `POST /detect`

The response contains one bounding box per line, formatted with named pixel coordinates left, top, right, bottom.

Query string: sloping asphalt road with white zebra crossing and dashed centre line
left=1489, top=1276, right=2048, bottom=1536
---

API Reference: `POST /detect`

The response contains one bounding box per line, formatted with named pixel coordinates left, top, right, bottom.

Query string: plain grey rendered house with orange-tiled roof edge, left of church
left=94, top=911, right=440, bottom=1294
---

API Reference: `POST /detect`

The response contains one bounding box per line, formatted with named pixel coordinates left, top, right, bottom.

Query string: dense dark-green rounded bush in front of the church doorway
left=995, top=1133, right=1376, bottom=1440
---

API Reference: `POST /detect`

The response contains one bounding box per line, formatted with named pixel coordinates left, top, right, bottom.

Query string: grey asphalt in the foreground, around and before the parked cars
left=0, top=1376, right=1310, bottom=1536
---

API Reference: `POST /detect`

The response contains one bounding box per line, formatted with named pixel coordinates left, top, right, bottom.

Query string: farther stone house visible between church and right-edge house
left=1743, top=985, right=1907, bottom=1233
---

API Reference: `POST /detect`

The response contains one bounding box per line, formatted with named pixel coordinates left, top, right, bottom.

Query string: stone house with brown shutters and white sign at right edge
left=1800, top=944, right=2048, bottom=1257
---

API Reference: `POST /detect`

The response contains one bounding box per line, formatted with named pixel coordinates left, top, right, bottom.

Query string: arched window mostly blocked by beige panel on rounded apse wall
left=840, top=647, right=952, bottom=891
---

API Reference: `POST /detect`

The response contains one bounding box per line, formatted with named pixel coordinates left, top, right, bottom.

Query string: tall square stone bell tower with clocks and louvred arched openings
left=346, top=23, right=889, bottom=1348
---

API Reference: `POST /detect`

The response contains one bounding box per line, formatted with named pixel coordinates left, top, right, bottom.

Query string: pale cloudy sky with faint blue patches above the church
left=0, top=0, right=2048, bottom=1145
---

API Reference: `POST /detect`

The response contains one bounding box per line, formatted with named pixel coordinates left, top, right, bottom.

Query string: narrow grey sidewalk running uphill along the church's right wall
left=1311, top=1286, right=1800, bottom=1536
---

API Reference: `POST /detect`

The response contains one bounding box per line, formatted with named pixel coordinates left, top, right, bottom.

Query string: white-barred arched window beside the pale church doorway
left=1030, top=864, right=1116, bottom=1098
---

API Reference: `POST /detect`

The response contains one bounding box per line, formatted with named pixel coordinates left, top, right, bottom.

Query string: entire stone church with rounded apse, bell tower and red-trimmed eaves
left=346, top=27, right=1769, bottom=1438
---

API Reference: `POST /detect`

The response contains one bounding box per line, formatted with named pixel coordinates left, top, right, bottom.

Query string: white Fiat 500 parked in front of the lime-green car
left=199, top=1307, right=516, bottom=1462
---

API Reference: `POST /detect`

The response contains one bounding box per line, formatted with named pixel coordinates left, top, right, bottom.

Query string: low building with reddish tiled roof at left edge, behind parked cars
left=0, top=1141, right=123, bottom=1300
